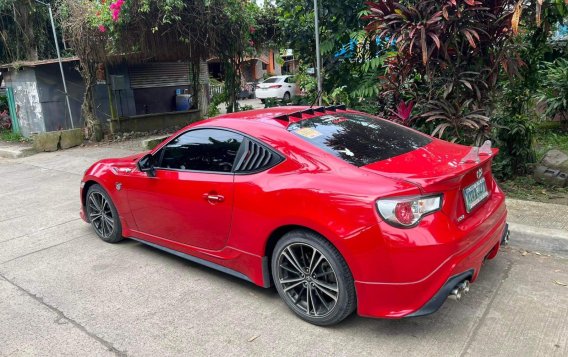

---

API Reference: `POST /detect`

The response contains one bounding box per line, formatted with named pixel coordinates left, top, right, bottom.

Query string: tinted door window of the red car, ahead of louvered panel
left=158, top=129, right=243, bottom=172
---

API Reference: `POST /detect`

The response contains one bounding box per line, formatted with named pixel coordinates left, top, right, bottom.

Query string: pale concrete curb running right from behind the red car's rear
left=509, top=222, right=568, bottom=255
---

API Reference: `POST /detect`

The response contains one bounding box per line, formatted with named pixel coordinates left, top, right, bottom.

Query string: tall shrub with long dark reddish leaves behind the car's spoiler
left=365, top=0, right=521, bottom=144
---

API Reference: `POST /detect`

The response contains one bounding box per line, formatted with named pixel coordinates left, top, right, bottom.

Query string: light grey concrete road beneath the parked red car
left=0, top=146, right=568, bottom=357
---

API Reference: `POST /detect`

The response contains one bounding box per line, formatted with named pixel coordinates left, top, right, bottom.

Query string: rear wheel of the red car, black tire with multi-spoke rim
left=271, top=230, right=357, bottom=326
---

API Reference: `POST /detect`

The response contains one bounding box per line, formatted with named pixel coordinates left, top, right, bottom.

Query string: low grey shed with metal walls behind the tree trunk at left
left=0, top=57, right=204, bottom=137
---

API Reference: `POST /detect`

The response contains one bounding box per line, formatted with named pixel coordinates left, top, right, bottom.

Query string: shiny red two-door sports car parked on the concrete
left=81, top=106, right=508, bottom=325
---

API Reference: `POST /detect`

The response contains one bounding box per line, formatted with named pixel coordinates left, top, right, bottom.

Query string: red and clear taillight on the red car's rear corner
left=377, top=195, right=442, bottom=228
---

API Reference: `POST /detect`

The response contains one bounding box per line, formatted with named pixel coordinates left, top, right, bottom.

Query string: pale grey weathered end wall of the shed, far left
left=4, top=68, right=45, bottom=137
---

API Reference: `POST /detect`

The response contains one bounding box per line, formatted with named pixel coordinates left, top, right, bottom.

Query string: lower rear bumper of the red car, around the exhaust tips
left=355, top=203, right=508, bottom=318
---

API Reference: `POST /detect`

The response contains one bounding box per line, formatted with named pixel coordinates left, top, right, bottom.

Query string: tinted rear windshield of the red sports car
left=288, top=113, right=432, bottom=166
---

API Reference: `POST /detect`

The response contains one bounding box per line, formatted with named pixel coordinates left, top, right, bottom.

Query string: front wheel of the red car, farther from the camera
left=85, top=184, right=123, bottom=243
